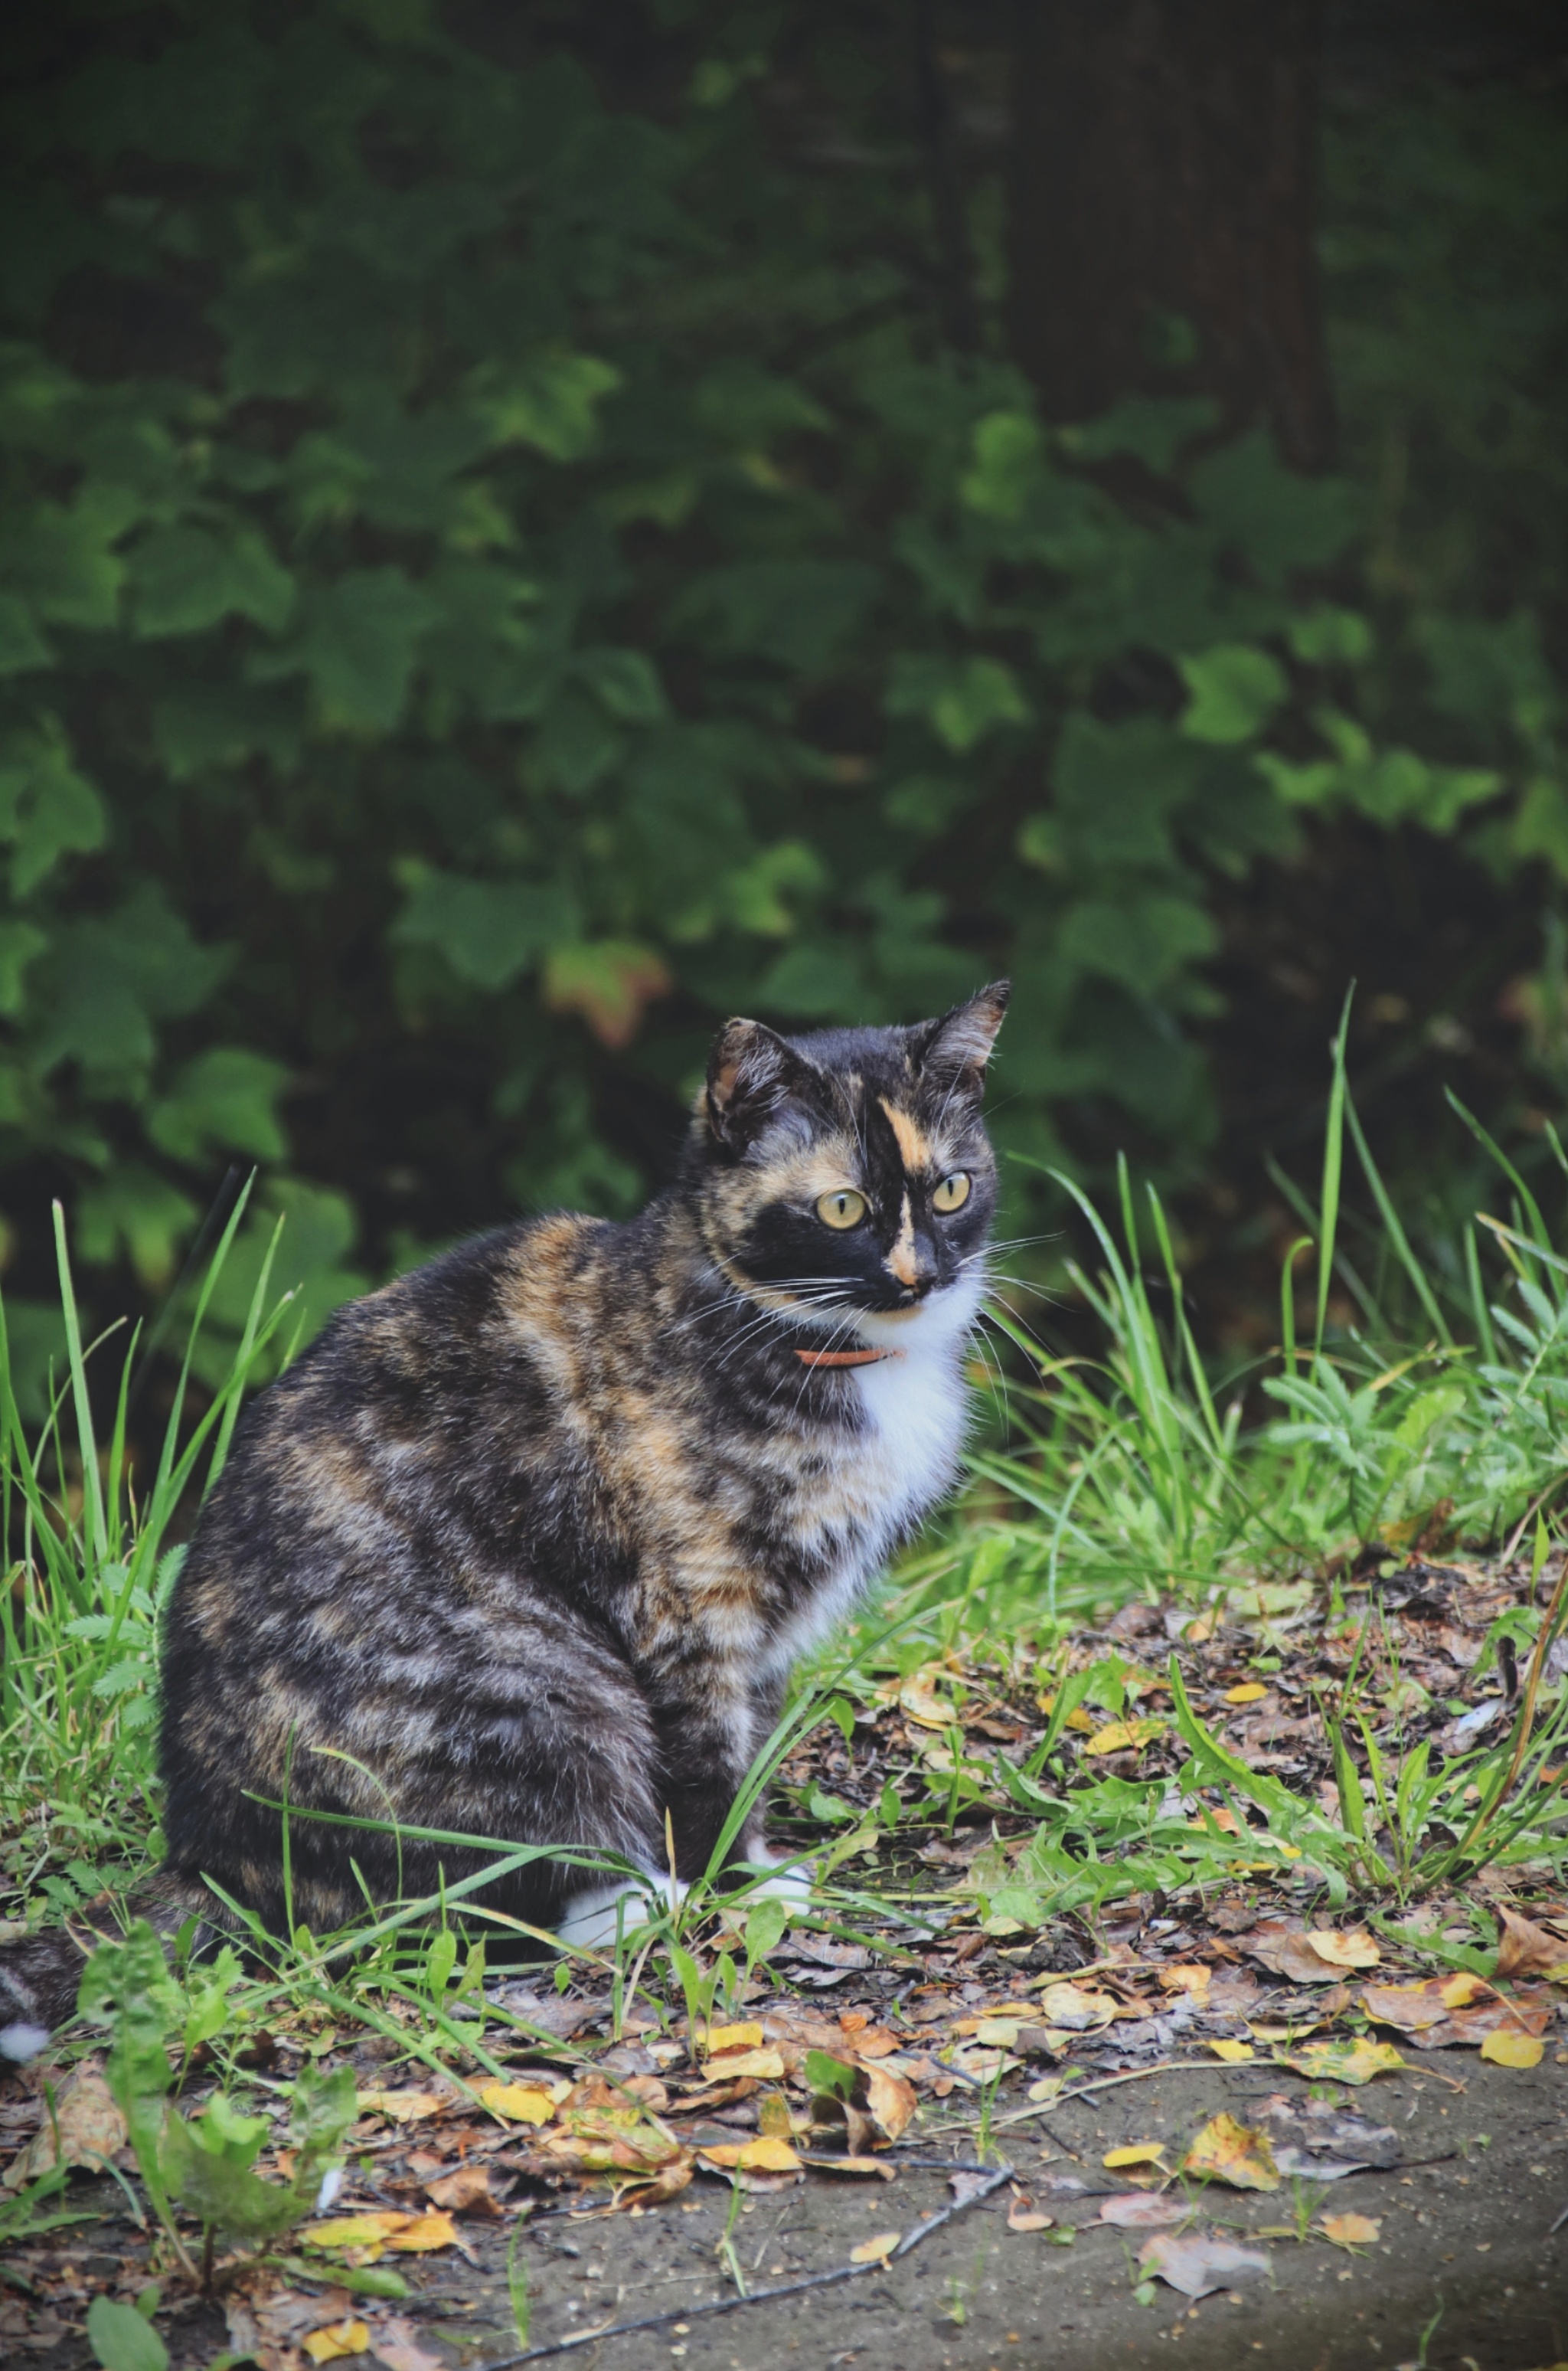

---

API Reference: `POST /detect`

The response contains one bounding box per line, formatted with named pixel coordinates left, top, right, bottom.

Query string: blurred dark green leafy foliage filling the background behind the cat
left=0, top=0, right=1568, bottom=1394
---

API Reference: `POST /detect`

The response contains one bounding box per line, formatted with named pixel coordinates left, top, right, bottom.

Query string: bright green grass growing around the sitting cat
left=0, top=1036, right=1568, bottom=2276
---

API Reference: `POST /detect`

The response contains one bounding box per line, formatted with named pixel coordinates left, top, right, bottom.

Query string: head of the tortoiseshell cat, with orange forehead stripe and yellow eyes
left=691, top=982, right=1008, bottom=1339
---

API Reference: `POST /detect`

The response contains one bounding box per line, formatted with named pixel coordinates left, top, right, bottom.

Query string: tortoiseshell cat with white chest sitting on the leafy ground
left=0, top=984, right=1008, bottom=2048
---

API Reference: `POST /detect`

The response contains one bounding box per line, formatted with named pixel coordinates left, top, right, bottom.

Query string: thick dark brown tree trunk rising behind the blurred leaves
left=1011, top=0, right=1333, bottom=469
